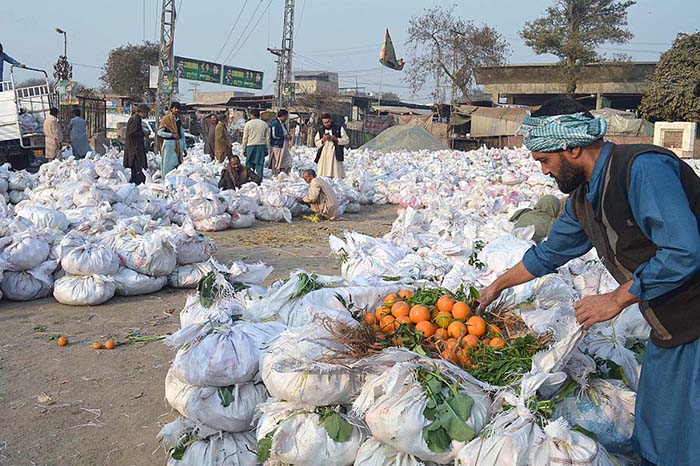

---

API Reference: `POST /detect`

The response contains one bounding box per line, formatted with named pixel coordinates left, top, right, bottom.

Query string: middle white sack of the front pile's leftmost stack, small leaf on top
left=165, top=369, right=267, bottom=432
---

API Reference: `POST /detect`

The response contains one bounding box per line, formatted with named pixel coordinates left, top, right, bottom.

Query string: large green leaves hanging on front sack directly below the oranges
left=416, top=369, right=474, bottom=452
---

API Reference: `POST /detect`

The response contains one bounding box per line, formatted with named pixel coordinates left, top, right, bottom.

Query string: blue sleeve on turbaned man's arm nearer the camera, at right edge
left=628, top=153, right=700, bottom=301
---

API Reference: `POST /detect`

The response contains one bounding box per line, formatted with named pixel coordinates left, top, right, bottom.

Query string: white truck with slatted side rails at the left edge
left=0, top=65, right=57, bottom=170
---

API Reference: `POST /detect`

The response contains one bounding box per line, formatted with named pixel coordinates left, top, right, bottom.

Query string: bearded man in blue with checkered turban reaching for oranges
left=480, top=98, right=700, bottom=466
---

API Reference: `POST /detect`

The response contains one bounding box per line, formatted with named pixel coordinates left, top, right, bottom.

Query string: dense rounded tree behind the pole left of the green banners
left=100, top=42, right=159, bottom=99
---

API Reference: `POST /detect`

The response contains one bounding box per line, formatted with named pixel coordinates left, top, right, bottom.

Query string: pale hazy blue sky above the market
left=0, top=0, right=700, bottom=102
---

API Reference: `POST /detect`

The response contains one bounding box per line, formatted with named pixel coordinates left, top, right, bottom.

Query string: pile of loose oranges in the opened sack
left=363, top=290, right=506, bottom=367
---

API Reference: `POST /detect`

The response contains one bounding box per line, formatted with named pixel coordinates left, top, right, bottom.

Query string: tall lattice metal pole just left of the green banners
left=156, top=0, right=176, bottom=127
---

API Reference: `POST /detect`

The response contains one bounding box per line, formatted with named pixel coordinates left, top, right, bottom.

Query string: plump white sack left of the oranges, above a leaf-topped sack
left=260, top=325, right=362, bottom=406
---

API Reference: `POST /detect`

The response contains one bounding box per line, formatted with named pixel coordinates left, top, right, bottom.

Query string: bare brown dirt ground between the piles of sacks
left=0, top=206, right=396, bottom=466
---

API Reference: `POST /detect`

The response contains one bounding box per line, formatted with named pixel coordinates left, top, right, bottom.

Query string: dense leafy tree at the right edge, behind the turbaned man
left=639, top=32, right=700, bottom=121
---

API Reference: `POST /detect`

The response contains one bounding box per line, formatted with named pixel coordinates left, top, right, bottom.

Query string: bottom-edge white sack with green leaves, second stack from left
left=257, top=401, right=364, bottom=466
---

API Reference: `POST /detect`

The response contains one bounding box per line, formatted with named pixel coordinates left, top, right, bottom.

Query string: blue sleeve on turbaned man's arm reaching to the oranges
left=523, top=199, right=593, bottom=277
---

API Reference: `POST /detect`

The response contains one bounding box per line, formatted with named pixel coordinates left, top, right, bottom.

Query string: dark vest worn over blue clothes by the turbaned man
left=571, top=144, right=700, bottom=348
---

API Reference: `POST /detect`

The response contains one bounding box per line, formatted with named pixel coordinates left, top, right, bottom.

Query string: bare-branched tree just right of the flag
left=399, top=5, right=510, bottom=102
